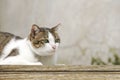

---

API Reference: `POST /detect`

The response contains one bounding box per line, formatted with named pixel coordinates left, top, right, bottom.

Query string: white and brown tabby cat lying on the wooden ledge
left=0, top=24, right=60, bottom=65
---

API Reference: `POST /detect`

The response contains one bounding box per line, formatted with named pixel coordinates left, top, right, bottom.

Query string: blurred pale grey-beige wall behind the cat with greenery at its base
left=0, top=0, right=120, bottom=65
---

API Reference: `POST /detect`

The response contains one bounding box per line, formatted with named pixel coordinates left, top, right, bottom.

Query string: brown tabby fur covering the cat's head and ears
left=28, top=24, right=60, bottom=48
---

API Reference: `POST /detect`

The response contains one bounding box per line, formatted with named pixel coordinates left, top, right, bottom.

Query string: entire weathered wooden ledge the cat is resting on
left=0, top=66, right=120, bottom=80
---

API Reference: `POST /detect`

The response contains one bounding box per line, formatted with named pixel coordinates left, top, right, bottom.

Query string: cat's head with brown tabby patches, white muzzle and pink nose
left=29, top=24, right=60, bottom=56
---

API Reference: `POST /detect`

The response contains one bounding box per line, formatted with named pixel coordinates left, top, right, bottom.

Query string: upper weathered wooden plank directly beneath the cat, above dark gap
left=0, top=65, right=120, bottom=72
